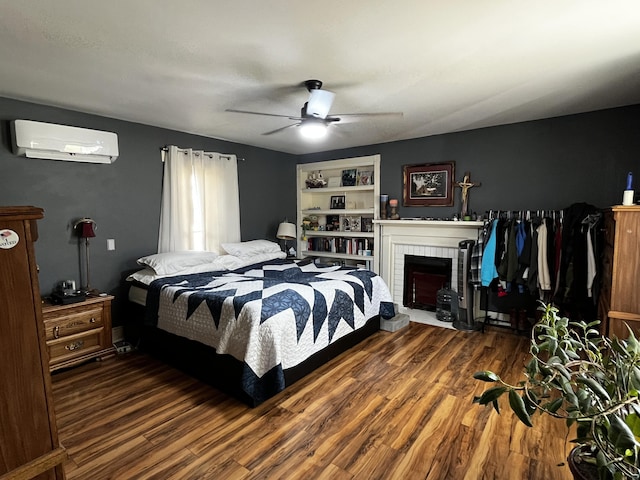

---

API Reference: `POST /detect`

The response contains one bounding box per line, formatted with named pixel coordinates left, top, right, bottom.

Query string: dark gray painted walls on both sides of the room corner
left=0, top=98, right=640, bottom=325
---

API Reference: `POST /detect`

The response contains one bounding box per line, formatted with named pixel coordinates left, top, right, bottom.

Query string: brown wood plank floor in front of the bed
left=48, top=323, right=572, bottom=480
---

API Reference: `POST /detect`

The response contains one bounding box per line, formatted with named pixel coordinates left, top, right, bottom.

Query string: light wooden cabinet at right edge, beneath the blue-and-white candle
left=598, top=205, right=640, bottom=338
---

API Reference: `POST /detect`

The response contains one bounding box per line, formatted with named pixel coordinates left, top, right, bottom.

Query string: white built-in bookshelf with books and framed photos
left=296, top=155, right=380, bottom=272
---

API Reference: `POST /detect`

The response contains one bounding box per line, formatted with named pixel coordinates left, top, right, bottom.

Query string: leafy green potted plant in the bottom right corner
left=473, top=303, right=640, bottom=479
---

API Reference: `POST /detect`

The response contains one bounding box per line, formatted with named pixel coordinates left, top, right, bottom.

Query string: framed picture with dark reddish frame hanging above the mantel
left=402, top=162, right=455, bottom=207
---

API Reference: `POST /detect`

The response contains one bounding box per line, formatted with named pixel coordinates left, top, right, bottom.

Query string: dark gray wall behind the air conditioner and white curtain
left=0, top=98, right=296, bottom=325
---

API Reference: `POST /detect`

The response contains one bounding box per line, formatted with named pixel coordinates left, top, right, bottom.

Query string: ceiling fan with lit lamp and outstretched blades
left=226, top=80, right=402, bottom=138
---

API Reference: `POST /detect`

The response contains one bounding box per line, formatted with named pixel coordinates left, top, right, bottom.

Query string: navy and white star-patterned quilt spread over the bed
left=147, top=260, right=394, bottom=401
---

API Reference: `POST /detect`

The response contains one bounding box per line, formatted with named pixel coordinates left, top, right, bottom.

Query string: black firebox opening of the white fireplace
left=402, top=255, right=452, bottom=311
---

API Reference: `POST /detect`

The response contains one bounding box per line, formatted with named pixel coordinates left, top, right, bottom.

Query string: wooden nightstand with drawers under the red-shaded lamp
left=42, top=295, right=115, bottom=372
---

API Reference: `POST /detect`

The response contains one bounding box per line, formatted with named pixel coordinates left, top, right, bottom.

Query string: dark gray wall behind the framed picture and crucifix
left=299, top=105, right=640, bottom=218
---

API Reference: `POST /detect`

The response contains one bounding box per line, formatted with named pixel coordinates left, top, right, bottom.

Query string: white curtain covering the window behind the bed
left=158, top=146, right=240, bottom=253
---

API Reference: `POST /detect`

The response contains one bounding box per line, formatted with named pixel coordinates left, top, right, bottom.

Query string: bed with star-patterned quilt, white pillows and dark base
left=129, top=240, right=394, bottom=406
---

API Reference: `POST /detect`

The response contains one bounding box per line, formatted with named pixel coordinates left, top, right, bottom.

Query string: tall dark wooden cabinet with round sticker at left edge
left=0, top=207, right=66, bottom=479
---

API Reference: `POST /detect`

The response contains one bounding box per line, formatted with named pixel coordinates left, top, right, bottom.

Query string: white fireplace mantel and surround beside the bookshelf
left=374, top=220, right=483, bottom=305
